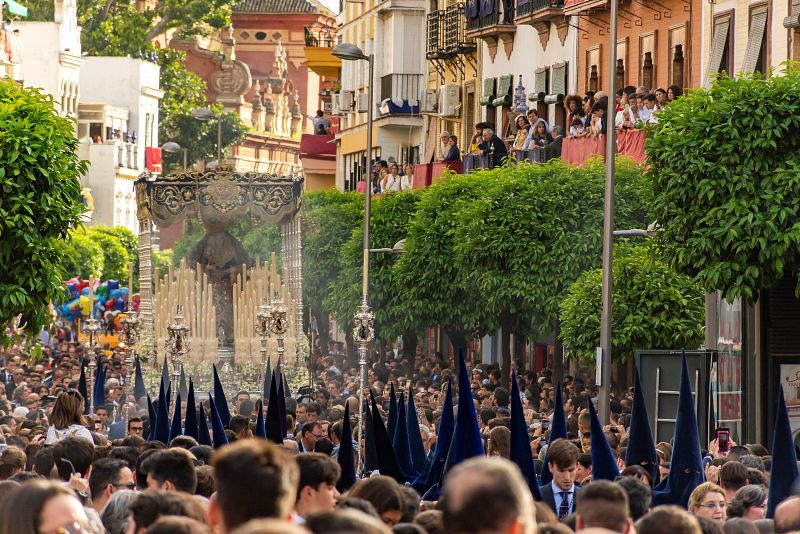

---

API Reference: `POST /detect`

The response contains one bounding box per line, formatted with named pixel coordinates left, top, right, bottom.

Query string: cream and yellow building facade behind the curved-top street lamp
left=332, top=0, right=428, bottom=190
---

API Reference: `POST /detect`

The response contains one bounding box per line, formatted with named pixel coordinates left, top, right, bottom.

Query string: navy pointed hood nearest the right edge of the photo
left=767, top=386, right=798, bottom=518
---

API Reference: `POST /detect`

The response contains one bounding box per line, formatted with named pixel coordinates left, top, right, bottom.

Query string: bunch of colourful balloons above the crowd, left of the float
left=56, top=278, right=139, bottom=326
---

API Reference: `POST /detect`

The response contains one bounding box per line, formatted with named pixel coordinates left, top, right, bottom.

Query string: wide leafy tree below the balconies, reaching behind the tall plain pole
left=454, top=159, right=645, bottom=381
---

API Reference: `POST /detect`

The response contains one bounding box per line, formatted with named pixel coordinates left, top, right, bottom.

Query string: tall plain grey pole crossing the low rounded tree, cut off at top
left=598, top=0, right=619, bottom=425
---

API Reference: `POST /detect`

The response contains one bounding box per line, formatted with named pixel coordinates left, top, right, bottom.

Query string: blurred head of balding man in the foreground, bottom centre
left=442, top=456, right=536, bottom=534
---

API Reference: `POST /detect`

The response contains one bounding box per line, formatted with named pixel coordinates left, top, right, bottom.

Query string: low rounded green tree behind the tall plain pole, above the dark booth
left=561, top=244, right=705, bottom=362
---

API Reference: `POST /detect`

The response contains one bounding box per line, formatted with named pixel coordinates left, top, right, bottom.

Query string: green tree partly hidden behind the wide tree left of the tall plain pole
left=387, top=171, right=491, bottom=354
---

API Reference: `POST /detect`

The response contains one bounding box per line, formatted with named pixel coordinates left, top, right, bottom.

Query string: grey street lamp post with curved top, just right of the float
left=331, top=43, right=375, bottom=478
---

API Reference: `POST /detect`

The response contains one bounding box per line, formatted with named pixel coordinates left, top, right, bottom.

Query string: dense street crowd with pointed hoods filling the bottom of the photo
left=0, top=326, right=800, bottom=534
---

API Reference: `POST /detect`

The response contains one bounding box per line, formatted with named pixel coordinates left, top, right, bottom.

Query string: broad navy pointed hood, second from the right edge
left=653, top=354, right=705, bottom=508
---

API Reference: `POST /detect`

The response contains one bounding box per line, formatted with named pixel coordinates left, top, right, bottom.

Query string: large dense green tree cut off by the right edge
left=646, top=70, right=800, bottom=302
